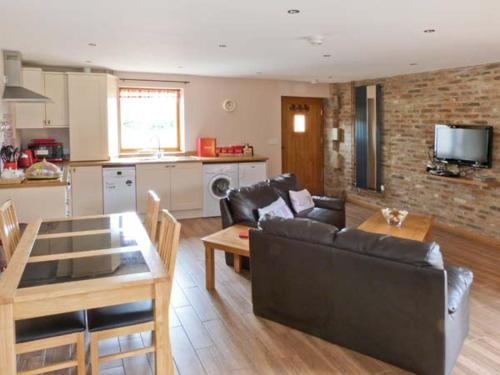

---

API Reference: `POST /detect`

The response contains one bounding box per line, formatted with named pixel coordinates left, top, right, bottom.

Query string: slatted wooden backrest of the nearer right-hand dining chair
left=157, top=210, right=181, bottom=279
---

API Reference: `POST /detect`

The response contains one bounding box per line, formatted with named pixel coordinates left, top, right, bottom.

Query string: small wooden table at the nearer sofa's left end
left=201, top=224, right=250, bottom=290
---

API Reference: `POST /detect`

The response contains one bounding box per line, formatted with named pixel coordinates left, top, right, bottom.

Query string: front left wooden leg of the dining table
left=0, top=304, right=17, bottom=375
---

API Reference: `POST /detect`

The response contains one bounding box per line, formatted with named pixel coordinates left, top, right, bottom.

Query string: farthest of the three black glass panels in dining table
left=38, top=216, right=125, bottom=234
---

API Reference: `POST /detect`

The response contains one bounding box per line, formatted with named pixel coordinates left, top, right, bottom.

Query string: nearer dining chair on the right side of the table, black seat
left=87, top=210, right=181, bottom=375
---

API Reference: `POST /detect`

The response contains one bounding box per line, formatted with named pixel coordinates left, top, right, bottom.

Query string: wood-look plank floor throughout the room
left=18, top=205, right=500, bottom=375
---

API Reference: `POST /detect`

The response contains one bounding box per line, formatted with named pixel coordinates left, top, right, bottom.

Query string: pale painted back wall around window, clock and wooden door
left=116, top=72, right=329, bottom=175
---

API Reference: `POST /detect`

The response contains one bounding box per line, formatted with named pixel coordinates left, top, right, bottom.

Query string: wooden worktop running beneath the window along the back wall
left=69, top=155, right=268, bottom=167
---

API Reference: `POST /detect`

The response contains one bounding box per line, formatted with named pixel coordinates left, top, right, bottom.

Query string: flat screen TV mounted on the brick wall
left=434, top=124, right=493, bottom=168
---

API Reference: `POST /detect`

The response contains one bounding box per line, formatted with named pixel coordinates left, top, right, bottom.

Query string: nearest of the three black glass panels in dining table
left=18, top=251, right=150, bottom=288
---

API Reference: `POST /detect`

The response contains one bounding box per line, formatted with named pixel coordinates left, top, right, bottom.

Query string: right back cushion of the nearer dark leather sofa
left=333, top=229, right=444, bottom=269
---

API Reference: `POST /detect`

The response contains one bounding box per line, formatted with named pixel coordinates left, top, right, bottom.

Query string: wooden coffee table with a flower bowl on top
left=358, top=211, right=434, bottom=242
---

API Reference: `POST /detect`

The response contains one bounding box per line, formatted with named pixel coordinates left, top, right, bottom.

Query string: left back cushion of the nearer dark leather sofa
left=259, top=215, right=338, bottom=246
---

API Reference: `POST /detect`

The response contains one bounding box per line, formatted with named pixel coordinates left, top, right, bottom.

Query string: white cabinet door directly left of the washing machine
left=170, top=163, right=203, bottom=211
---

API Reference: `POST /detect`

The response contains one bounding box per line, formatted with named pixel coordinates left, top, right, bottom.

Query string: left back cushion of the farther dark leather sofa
left=227, top=182, right=279, bottom=225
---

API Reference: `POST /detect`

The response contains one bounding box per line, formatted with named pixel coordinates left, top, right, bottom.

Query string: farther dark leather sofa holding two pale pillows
left=220, top=173, right=345, bottom=269
